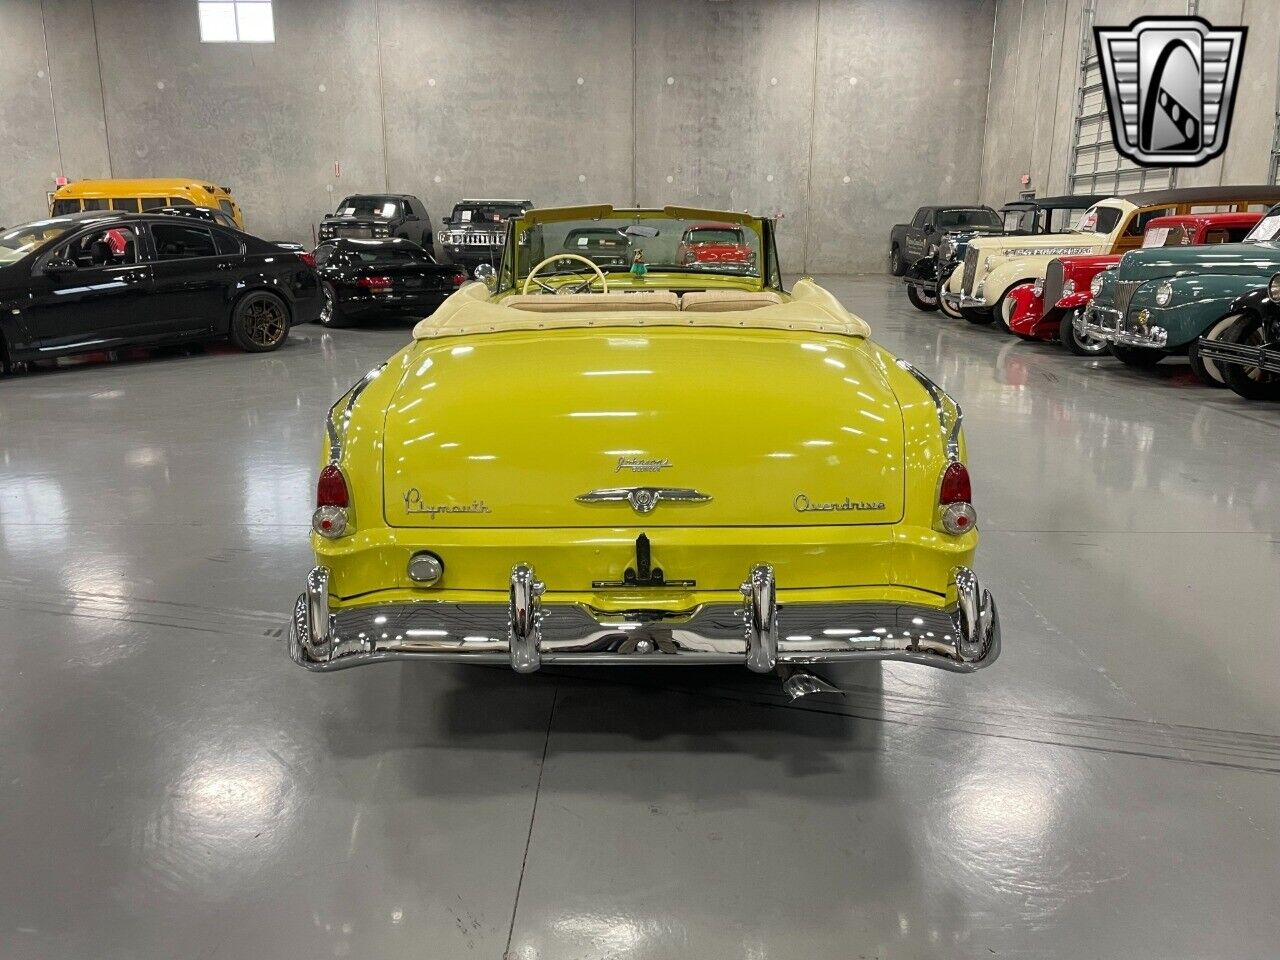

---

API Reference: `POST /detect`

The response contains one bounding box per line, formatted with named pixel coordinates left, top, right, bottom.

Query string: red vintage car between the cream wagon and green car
left=1009, top=212, right=1262, bottom=356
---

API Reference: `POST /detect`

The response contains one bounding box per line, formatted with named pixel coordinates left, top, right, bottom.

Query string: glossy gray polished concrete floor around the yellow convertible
left=0, top=278, right=1280, bottom=960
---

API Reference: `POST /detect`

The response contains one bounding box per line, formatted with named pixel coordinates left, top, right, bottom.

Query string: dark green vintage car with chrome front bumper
left=1075, top=205, right=1280, bottom=387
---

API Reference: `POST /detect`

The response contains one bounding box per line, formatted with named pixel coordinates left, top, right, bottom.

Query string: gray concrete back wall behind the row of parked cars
left=0, top=0, right=993, bottom=271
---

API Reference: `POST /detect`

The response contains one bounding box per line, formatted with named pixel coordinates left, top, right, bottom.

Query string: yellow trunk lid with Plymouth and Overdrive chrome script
left=383, top=328, right=904, bottom=527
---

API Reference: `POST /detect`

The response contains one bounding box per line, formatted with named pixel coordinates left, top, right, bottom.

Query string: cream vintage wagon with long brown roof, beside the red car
left=942, top=184, right=1280, bottom=328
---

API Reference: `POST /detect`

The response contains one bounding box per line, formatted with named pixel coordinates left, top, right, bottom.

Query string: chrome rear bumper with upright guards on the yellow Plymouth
left=288, top=564, right=1000, bottom=673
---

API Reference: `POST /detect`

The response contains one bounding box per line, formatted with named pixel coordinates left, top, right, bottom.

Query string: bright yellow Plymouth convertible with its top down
left=288, top=206, right=1000, bottom=695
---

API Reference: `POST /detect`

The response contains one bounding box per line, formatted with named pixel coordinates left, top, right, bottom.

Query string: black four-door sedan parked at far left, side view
left=0, top=210, right=321, bottom=366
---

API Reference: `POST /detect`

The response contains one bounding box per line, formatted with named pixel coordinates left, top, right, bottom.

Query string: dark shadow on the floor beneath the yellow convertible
left=317, top=663, right=884, bottom=794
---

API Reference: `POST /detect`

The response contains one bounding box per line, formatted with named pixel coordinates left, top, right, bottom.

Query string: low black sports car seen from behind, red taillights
left=315, top=237, right=467, bottom=326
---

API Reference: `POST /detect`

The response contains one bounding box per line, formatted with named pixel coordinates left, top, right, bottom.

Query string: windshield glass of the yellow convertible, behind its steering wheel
left=518, top=216, right=763, bottom=276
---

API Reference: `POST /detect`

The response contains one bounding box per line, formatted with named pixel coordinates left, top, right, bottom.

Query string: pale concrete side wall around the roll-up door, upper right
left=980, top=0, right=1280, bottom=204
